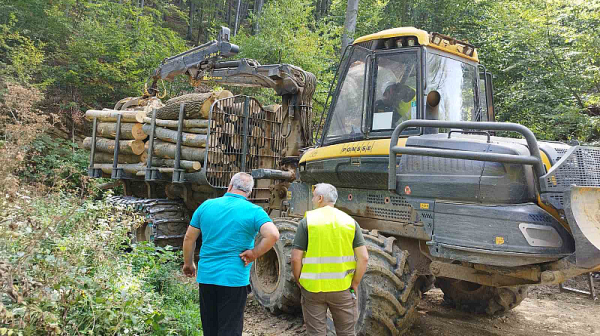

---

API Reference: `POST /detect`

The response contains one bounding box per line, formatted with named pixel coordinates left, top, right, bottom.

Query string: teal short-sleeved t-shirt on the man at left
left=190, top=193, right=271, bottom=287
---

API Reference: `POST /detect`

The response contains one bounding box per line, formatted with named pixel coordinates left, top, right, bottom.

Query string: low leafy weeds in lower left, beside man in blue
left=0, top=190, right=200, bottom=335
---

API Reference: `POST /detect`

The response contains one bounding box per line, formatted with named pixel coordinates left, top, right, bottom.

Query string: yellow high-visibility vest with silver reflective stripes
left=300, top=206, right=356, bottom=293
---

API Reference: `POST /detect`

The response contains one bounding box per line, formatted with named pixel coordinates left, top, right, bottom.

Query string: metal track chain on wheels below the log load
left=107, top=196, right=190, bottom=248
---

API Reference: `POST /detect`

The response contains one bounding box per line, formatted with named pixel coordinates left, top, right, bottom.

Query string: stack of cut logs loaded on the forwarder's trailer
left=83, top=90, right=233, bottom=176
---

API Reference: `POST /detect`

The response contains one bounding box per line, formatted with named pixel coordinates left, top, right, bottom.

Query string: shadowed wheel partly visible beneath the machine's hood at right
left=435, top=278, right=527, bottom=315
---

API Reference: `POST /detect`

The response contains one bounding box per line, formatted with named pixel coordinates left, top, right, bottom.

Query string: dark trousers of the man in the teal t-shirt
left=199, top=284, right=248, bottom=336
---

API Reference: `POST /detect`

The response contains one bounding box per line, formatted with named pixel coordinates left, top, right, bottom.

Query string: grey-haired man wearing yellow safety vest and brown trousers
left=292, top=183, right=369, bottom=336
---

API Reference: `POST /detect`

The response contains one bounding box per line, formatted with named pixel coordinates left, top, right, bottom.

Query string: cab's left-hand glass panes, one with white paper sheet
left=324, top=47, right=418, bottom=143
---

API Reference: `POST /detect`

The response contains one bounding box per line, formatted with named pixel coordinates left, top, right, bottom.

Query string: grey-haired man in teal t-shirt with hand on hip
left=183, top=173, right=279, bottom=336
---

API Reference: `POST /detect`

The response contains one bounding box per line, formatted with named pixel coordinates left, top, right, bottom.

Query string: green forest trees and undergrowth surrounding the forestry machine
left=0, top=0, right=600, bottom=335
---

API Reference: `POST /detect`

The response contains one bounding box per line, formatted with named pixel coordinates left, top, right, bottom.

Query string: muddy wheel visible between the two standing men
left=250, top=218, right=301, bottom=315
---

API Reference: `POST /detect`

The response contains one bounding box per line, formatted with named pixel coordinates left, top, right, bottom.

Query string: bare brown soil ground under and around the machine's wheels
left=243, top=276, right=600, bottom=336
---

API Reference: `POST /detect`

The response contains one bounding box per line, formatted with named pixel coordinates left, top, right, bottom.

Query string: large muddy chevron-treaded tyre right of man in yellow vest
left=346, top=230, right=421, bottom=335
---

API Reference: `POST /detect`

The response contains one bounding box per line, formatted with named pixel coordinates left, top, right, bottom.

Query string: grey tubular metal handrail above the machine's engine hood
left=388, top=119, right=545, bottom=190
